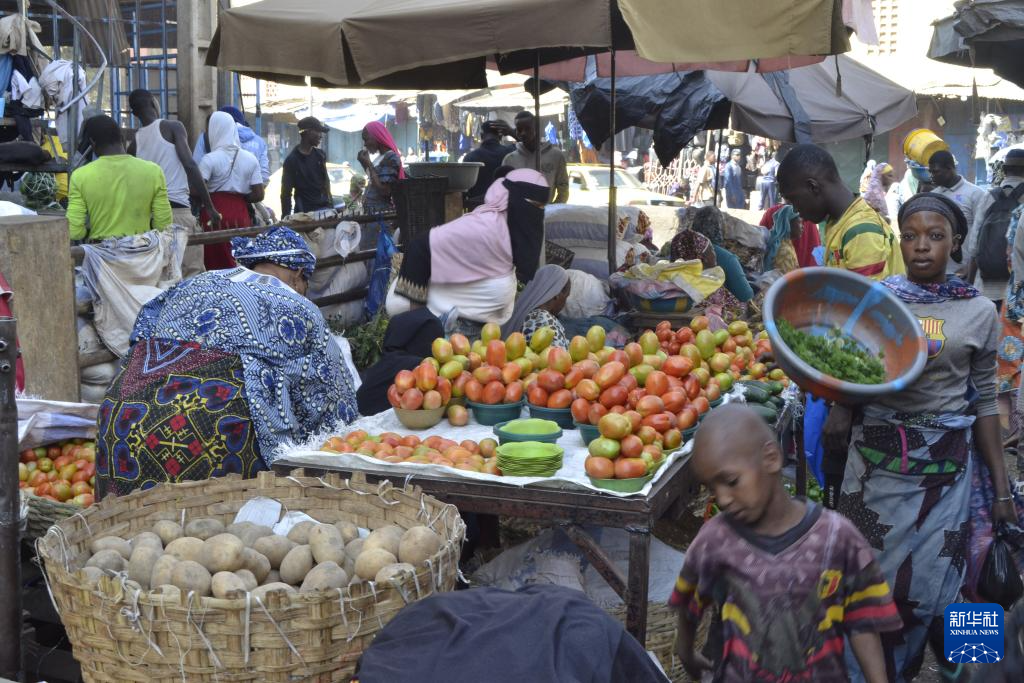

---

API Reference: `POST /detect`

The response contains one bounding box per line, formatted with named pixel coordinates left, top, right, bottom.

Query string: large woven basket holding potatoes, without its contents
left=37, top=470, right=465, bottom=683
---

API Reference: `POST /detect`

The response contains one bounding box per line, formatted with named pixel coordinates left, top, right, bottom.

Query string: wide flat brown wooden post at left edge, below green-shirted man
left=0, top=216, right=79, bottom=401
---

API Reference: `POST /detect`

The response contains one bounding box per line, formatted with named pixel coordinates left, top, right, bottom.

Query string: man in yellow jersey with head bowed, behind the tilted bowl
left=778, top=144, right=904, bottom=280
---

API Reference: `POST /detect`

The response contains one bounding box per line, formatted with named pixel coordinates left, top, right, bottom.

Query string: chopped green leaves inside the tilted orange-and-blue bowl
left=778, top=321, right=886, bottom=384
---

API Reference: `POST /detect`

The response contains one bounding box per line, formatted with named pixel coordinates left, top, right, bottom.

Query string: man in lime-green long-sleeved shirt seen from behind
left=68, top=116, right=173, bottom=241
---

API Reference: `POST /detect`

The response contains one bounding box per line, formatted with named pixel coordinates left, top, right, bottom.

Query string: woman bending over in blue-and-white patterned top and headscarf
left=96, top=227, right=358, bottom=496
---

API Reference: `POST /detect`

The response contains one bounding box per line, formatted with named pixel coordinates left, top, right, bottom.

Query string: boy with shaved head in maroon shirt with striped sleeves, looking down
left=669, top=404, right=901, bottom=683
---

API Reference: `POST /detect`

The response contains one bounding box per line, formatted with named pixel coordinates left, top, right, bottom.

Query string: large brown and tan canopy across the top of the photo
left=207, top=0, right=866, bottom=88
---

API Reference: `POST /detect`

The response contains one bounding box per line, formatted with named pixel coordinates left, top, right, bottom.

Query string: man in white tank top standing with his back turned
left=128, top=90, right=220, bottom=278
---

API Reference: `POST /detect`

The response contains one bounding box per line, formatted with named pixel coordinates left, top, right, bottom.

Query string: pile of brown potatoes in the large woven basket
left=82, top=519, right=441, bottom=598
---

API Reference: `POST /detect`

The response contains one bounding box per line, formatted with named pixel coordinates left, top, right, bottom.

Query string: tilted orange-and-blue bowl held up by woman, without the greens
left=764, top=268, right=928, bottom=404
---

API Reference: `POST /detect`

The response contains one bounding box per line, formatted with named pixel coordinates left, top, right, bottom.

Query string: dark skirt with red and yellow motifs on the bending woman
left=96, top=339, right=266, bottom=496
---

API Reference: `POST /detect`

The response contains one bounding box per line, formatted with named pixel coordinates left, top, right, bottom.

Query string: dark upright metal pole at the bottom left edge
left=0, top=317, right=22, bottom=680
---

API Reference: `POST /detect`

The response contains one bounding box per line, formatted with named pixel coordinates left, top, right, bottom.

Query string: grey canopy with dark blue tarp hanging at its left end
left=571, top=55, right=918, bottom=163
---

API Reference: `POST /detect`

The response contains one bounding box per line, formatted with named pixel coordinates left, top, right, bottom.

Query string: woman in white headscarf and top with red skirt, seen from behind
left=199, top=112, right=263, bottom=270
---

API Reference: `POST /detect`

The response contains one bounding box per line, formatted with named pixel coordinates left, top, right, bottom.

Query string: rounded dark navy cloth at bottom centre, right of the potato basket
left=356, top=586, right=668, bottom=683
